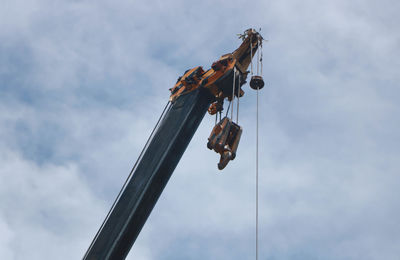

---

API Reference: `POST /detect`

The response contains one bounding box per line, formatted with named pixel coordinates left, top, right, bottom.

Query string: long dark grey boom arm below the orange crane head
left=83, top=88, right=212, bottom=260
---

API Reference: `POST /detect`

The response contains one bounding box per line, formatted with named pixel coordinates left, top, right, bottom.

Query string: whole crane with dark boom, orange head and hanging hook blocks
left=83, top=29, right=264, bottom=260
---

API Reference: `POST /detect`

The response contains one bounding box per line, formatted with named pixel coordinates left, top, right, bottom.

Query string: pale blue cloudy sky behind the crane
left=0, top=0, right=400, bottom=260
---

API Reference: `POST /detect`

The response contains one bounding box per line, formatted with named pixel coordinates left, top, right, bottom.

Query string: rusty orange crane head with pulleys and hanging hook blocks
left=170, top=29, right=264, bottom=170
